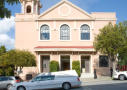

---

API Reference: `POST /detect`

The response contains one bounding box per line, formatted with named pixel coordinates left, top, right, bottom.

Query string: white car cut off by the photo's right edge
left=113, top=71, right=127, bottom=80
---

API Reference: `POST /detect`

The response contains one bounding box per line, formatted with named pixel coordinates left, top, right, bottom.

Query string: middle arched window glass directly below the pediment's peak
left=60, top=24, right=70, bottom=40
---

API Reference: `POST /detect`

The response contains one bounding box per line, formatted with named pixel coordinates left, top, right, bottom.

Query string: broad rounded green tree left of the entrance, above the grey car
left=0, top=49, right=36, bottom=75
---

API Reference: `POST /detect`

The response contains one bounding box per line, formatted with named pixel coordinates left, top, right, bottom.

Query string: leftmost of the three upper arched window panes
left=40, top=25, right=50, bottom=40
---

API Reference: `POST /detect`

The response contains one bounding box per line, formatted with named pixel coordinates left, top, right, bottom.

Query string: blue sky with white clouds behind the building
left=0, top=0, right=127, bottom=50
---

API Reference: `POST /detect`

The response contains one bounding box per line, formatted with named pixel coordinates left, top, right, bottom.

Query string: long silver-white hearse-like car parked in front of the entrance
left=11, top=70, right=81, bottom=90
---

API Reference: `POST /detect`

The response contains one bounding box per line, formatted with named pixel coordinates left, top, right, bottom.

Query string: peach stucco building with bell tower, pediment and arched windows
left=15, top=0, right=116, bottom=77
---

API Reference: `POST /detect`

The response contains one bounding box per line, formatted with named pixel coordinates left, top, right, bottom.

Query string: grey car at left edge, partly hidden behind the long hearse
left=0, top=76, right=21, bottom=89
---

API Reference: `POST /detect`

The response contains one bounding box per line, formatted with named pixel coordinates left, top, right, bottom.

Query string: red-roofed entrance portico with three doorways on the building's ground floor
left=35, top=46, right=95, bottom=73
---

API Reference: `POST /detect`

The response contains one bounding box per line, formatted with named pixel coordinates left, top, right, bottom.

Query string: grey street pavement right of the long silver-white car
left=2, top=78, right=127, bottom=90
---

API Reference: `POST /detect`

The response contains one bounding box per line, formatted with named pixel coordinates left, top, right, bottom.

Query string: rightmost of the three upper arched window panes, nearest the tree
left=80, top=24, right=90, bottom=40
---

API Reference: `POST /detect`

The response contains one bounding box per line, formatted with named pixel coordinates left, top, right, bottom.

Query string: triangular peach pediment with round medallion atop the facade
left=38, top=0, right=93, bottom=20
